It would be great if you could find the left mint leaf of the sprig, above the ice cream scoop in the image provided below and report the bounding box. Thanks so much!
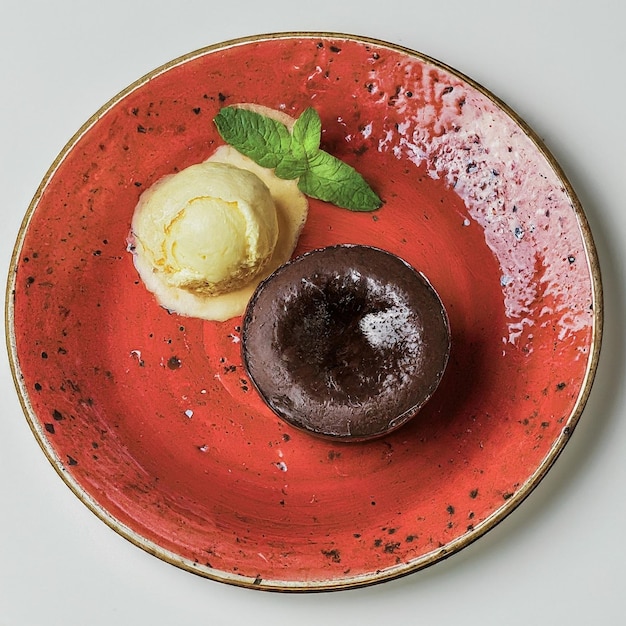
[214,107,291,168]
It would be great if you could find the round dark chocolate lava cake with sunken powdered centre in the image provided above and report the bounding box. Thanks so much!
[242,245,450,441]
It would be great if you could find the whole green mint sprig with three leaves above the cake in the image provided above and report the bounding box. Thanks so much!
[214,107,382,211]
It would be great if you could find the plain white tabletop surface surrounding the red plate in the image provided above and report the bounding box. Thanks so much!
[0,0,626,626]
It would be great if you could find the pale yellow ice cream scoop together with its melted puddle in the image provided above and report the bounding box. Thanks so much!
[130,106,308,321]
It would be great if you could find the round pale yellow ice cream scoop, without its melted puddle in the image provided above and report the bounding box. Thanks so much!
[132,162,278,296]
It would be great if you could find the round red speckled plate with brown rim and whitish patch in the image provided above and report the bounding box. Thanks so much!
[6,33,602,591]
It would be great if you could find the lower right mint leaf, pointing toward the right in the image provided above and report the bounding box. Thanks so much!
[298,150,382,211]
